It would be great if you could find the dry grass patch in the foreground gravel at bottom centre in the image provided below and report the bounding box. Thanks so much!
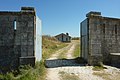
[59,71,79,80]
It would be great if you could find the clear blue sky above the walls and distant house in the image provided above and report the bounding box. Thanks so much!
[0,0,120,37]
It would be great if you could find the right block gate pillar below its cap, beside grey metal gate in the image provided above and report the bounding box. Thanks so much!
[88,16,103,65]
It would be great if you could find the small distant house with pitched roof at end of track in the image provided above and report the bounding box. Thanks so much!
[55,33,71,42]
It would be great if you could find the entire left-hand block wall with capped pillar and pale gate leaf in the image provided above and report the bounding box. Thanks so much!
[0,7,42,72]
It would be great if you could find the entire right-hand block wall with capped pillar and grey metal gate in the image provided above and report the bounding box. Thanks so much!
[81,12,120,65]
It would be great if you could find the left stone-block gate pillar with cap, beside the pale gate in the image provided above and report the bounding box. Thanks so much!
[15,9,36,66]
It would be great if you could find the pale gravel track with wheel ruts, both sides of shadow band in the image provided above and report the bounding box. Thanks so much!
[46,42,120,80]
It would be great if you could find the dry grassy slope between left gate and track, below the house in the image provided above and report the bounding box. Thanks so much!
[42,37,68,59]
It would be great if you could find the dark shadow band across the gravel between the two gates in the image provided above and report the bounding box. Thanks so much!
[45,58,86,68]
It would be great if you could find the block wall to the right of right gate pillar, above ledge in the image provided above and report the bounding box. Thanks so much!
[102,18,120,63]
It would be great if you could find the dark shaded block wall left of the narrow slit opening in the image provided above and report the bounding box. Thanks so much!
[0,12,19,72]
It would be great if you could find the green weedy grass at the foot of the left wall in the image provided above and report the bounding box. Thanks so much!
[0,62,45,80]
